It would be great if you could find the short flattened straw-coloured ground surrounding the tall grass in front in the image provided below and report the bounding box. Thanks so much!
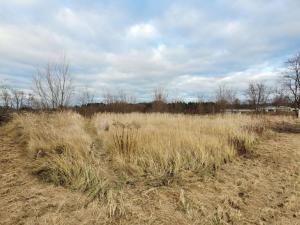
[0,125,300,225]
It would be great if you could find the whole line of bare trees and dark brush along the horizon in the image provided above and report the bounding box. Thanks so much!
[0,53,300,115]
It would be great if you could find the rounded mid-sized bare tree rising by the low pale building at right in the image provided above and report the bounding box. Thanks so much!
[246,82,270,111]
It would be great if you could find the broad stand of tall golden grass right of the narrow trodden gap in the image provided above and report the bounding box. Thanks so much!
[92,113,266,177]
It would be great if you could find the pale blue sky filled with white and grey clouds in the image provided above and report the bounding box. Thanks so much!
[0,0,300,101]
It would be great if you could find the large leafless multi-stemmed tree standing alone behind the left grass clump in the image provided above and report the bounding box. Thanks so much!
[33,57,73,109]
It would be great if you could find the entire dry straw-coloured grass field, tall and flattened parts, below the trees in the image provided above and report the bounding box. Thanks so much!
[0,112,300,224]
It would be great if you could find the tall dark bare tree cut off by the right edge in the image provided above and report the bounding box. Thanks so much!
[284,53,300,109]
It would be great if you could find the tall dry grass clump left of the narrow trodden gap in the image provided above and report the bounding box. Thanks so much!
[5,112,113,200]
